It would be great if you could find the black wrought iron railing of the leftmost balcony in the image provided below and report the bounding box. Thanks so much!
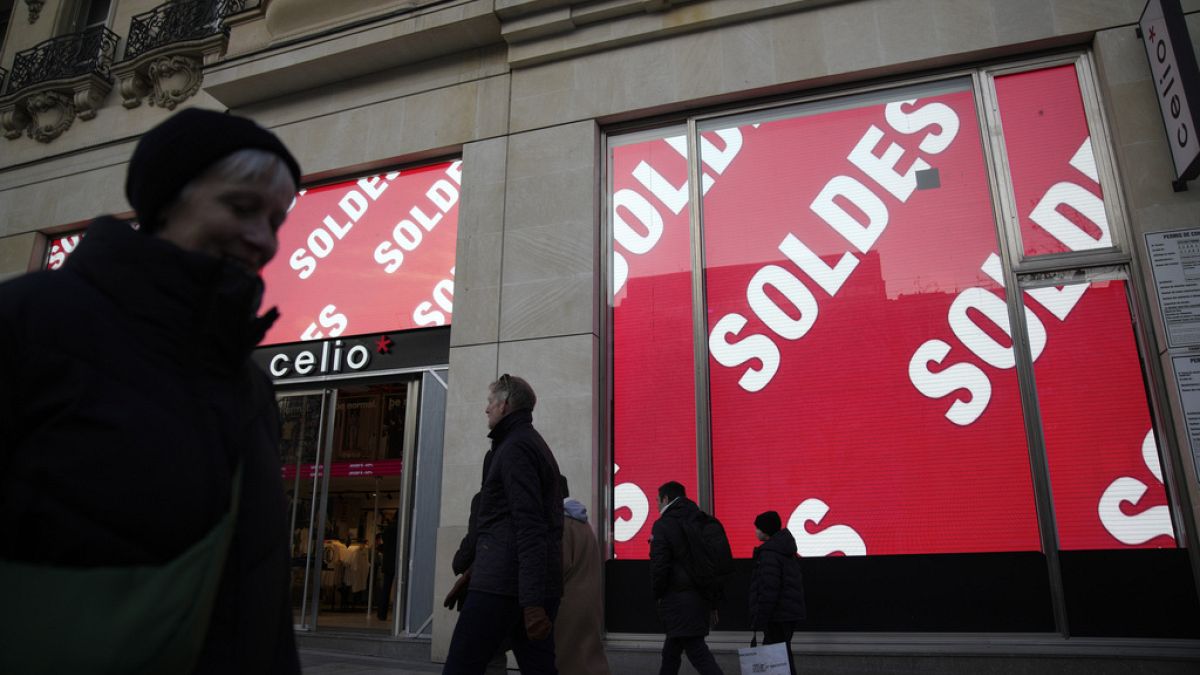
[6,25,120,94]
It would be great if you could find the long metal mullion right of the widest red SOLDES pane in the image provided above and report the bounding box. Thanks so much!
[973,65,1070,637]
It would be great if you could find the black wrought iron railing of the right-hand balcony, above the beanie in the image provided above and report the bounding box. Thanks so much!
[125,0,260,60]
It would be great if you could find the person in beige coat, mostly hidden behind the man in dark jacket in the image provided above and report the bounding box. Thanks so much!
[554,477,610,675]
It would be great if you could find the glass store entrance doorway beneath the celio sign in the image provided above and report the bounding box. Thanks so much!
[278,380,420,634]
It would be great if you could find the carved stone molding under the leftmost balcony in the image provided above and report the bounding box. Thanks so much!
[0,74,113,143]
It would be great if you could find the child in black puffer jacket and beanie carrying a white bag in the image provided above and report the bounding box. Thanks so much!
[750,510,805,675]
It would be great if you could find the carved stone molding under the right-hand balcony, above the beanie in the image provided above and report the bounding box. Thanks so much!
[113,34,229,110]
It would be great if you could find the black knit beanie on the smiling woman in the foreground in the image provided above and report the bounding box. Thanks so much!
[125,108,300,233]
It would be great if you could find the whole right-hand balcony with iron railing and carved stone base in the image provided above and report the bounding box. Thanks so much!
[113,0,260,109]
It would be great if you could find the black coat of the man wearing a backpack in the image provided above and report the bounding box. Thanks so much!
[650,497,714,638]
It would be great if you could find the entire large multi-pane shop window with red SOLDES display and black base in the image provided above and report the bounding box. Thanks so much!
[608,58,1200,637]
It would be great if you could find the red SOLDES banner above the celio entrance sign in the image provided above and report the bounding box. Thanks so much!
[263,161,462,345]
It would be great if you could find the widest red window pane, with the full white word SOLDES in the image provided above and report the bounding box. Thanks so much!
[703,82,1039,556]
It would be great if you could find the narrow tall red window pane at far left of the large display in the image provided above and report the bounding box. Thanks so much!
[611,127,696,558]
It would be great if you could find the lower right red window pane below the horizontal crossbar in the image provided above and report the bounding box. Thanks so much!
[1034,280,1175,550]
